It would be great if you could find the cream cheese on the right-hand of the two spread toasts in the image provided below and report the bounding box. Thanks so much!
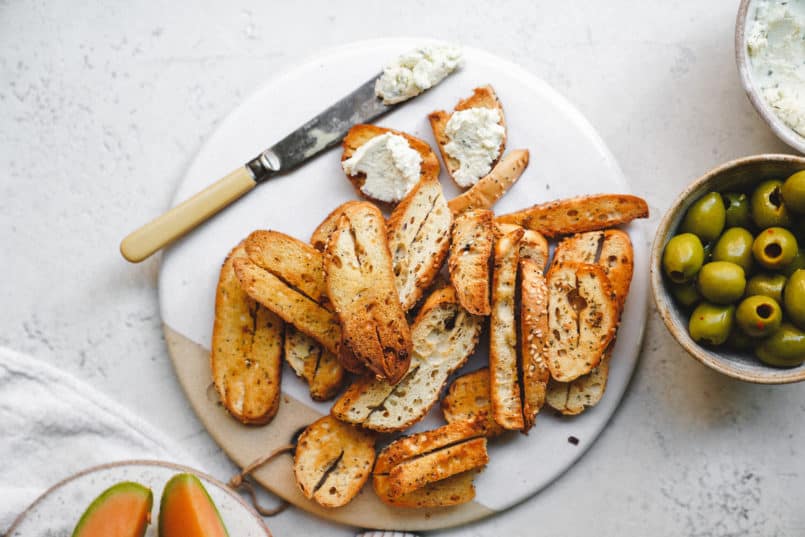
[444,107,506,188]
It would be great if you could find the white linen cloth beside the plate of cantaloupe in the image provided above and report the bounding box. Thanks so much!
[0,347,197,534]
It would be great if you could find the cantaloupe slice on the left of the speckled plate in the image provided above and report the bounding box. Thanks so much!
[73,481,154,537]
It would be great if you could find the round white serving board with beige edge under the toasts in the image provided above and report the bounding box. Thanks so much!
[159,38,648,530]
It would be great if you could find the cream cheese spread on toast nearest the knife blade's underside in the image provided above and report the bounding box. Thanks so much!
[341,132,422,203]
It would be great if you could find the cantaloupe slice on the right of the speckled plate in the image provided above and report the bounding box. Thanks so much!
[159,474,229,537]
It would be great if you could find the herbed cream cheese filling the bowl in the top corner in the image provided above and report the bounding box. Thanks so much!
[746,0,805,136]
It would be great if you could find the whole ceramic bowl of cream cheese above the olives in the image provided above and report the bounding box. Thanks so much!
[735,0,805,153]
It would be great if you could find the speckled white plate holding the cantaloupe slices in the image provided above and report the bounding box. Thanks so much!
[6,461,271,537]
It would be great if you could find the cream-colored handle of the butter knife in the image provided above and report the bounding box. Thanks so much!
[120,166,257,263]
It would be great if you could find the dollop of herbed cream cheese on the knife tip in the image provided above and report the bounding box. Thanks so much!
[375,45,461,104]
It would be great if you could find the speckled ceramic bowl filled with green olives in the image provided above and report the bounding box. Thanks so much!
[651,155,805,384]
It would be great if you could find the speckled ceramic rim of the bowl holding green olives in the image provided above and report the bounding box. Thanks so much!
[650,154,805,384]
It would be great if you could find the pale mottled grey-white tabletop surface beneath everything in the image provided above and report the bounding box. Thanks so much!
[0,0,805,537]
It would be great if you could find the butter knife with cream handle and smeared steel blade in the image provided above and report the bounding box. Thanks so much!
[120,74,392,263]
